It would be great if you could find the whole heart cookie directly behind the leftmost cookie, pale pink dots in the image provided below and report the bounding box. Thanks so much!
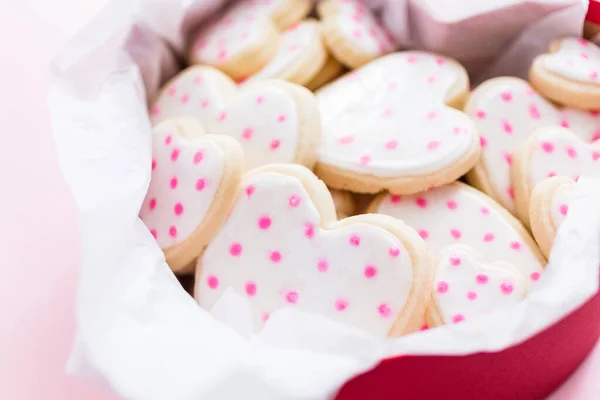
[150,66,321,168]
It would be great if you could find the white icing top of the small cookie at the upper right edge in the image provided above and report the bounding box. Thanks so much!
[543,38,600,83]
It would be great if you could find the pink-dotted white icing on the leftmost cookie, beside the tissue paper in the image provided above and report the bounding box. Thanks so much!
[140,122,225,249]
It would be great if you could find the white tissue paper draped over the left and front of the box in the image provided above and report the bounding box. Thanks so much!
[48,0,600,400]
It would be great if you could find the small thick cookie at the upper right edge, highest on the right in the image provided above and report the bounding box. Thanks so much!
[529,38,600,110]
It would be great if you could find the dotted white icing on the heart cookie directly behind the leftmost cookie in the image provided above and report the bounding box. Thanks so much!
[151,67,300,169]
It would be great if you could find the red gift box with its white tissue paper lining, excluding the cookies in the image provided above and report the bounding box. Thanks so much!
[49,0,600,400]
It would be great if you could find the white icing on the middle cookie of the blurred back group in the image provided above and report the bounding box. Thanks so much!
[244,21,321,83]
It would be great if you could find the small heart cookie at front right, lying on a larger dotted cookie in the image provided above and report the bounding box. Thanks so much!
[427,245,527,327]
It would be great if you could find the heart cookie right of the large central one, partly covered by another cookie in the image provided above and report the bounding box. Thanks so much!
[465,77,600,213]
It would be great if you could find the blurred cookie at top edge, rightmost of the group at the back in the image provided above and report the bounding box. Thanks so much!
[317,0,396,69]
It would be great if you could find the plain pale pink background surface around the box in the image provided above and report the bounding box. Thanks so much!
[0,0,600,400]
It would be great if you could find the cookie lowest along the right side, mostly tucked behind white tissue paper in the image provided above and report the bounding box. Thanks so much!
[529,176,576,257]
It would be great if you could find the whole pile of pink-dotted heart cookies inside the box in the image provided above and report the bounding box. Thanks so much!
[140,0,600,336]
